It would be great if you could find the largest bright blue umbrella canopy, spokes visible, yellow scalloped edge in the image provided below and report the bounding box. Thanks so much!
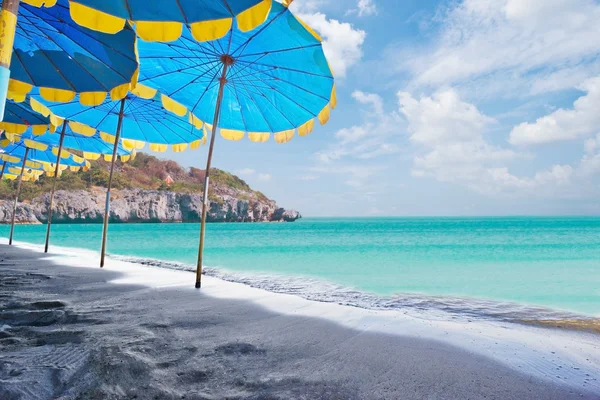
[138,2,336,142]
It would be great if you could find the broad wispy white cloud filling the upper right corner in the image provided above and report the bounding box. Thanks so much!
[393,0,600,97]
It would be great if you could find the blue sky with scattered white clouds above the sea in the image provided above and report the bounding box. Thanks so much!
[165,0,600,216]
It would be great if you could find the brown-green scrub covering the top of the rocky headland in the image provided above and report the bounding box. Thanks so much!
[0,153,268,202]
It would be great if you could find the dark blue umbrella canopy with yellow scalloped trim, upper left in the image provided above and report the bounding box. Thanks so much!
[4,0,138,105]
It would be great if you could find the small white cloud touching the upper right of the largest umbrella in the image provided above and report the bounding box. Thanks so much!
[292,11,367,78]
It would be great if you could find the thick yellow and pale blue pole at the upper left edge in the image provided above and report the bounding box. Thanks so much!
[0,0,20,121]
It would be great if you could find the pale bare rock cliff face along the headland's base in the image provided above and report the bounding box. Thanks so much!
[0,188,301,224]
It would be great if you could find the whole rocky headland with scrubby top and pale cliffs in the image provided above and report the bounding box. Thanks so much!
[0,153,300,224]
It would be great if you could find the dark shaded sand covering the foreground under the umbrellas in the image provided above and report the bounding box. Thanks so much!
[0,245,598,400]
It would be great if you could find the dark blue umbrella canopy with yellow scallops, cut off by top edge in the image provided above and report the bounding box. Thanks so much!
[25,0,272,42]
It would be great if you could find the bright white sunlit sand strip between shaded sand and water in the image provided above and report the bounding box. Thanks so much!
[0,239,600,394]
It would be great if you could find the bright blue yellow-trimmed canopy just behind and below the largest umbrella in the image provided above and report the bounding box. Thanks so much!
[29,85,204,151]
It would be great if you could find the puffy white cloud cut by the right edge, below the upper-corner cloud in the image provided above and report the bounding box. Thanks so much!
[510,76,600,146]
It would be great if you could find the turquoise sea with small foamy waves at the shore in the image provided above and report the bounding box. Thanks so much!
[0,217,600,318]
